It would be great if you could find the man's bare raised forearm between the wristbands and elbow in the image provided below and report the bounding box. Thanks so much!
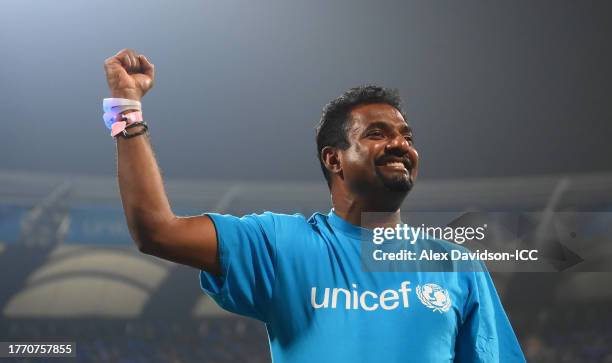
[117,135,174,250]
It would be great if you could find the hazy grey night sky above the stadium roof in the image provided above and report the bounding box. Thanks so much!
[0,0,612,180]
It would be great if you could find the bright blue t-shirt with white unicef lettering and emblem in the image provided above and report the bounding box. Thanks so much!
[200,211,525,363]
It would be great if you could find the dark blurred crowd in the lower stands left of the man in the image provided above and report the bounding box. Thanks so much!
[0,318,270,363]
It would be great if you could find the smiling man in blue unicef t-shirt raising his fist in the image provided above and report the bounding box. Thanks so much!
[105,49,524,363]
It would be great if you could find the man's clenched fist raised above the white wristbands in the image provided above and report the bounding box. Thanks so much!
[104,49,155,101]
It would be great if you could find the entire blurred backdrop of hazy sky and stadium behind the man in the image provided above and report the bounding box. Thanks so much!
[0,0,612,363]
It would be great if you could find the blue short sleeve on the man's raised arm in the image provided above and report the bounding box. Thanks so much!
[200,212,276,321]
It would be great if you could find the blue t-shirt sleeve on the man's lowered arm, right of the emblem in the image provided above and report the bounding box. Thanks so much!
[455,264,525,363]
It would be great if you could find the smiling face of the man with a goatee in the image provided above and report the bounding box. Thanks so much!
[339,103,419,194]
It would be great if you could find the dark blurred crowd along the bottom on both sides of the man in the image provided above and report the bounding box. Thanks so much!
[0,303,612,363]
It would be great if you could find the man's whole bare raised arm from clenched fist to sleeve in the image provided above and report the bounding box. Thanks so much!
[104,49,219,273]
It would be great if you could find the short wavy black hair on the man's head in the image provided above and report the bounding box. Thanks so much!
[316,85,406,187]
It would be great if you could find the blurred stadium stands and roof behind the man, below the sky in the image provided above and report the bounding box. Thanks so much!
[0,172,612,362]
